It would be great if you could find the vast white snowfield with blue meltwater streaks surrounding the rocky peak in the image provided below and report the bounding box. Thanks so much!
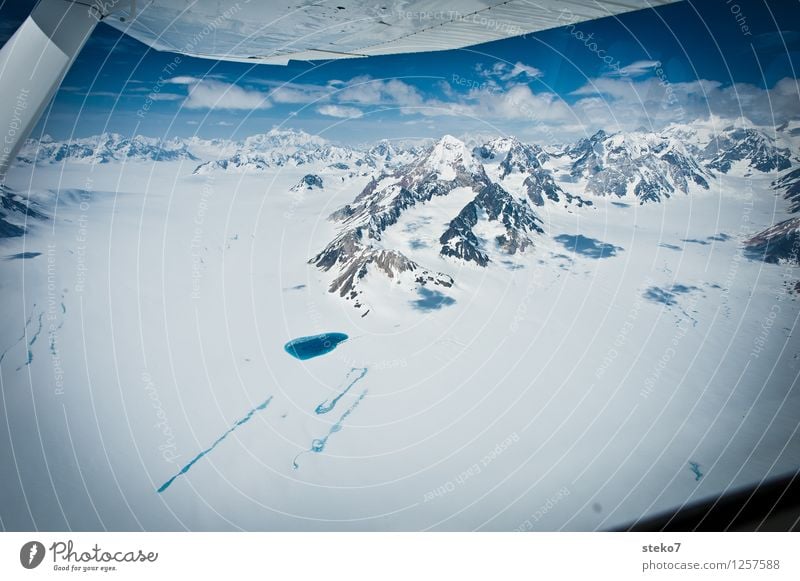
[0,125,800,530]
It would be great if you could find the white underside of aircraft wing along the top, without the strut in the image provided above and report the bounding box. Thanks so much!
[105,0,674,64]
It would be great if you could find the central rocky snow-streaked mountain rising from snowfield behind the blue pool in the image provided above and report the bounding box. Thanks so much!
[310,135,543,306]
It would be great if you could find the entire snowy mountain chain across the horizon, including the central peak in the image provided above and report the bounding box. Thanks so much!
[7,122,800,300]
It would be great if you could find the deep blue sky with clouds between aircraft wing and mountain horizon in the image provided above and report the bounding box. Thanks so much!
[0,0,800,143]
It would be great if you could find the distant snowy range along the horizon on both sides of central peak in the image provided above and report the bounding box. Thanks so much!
[18,124,800,182]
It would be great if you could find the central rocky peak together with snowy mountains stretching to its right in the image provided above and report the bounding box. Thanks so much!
[310,125,800,310]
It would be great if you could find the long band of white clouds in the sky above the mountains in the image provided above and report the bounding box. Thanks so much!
[168,68,800,140]
